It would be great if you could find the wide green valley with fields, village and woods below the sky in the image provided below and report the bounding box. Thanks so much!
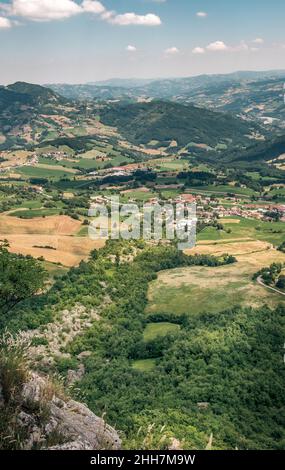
[0,72,285,450]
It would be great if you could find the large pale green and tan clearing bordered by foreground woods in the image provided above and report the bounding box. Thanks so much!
[146,248,285,316]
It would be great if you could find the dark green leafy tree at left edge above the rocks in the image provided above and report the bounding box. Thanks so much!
[0,240,46,313]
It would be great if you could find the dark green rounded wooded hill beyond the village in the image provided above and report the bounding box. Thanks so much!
[100,101,256,147]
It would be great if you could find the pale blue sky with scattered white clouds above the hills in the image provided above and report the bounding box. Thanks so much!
[0,0,285,84]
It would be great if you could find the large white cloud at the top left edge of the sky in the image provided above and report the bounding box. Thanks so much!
[11,0,82,21]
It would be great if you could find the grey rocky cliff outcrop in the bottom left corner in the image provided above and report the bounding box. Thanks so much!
[0,373,121,450]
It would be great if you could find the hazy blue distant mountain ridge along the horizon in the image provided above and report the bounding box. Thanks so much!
[45,70,285,128]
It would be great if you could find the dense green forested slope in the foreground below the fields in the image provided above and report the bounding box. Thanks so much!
[0,241,285,449]
